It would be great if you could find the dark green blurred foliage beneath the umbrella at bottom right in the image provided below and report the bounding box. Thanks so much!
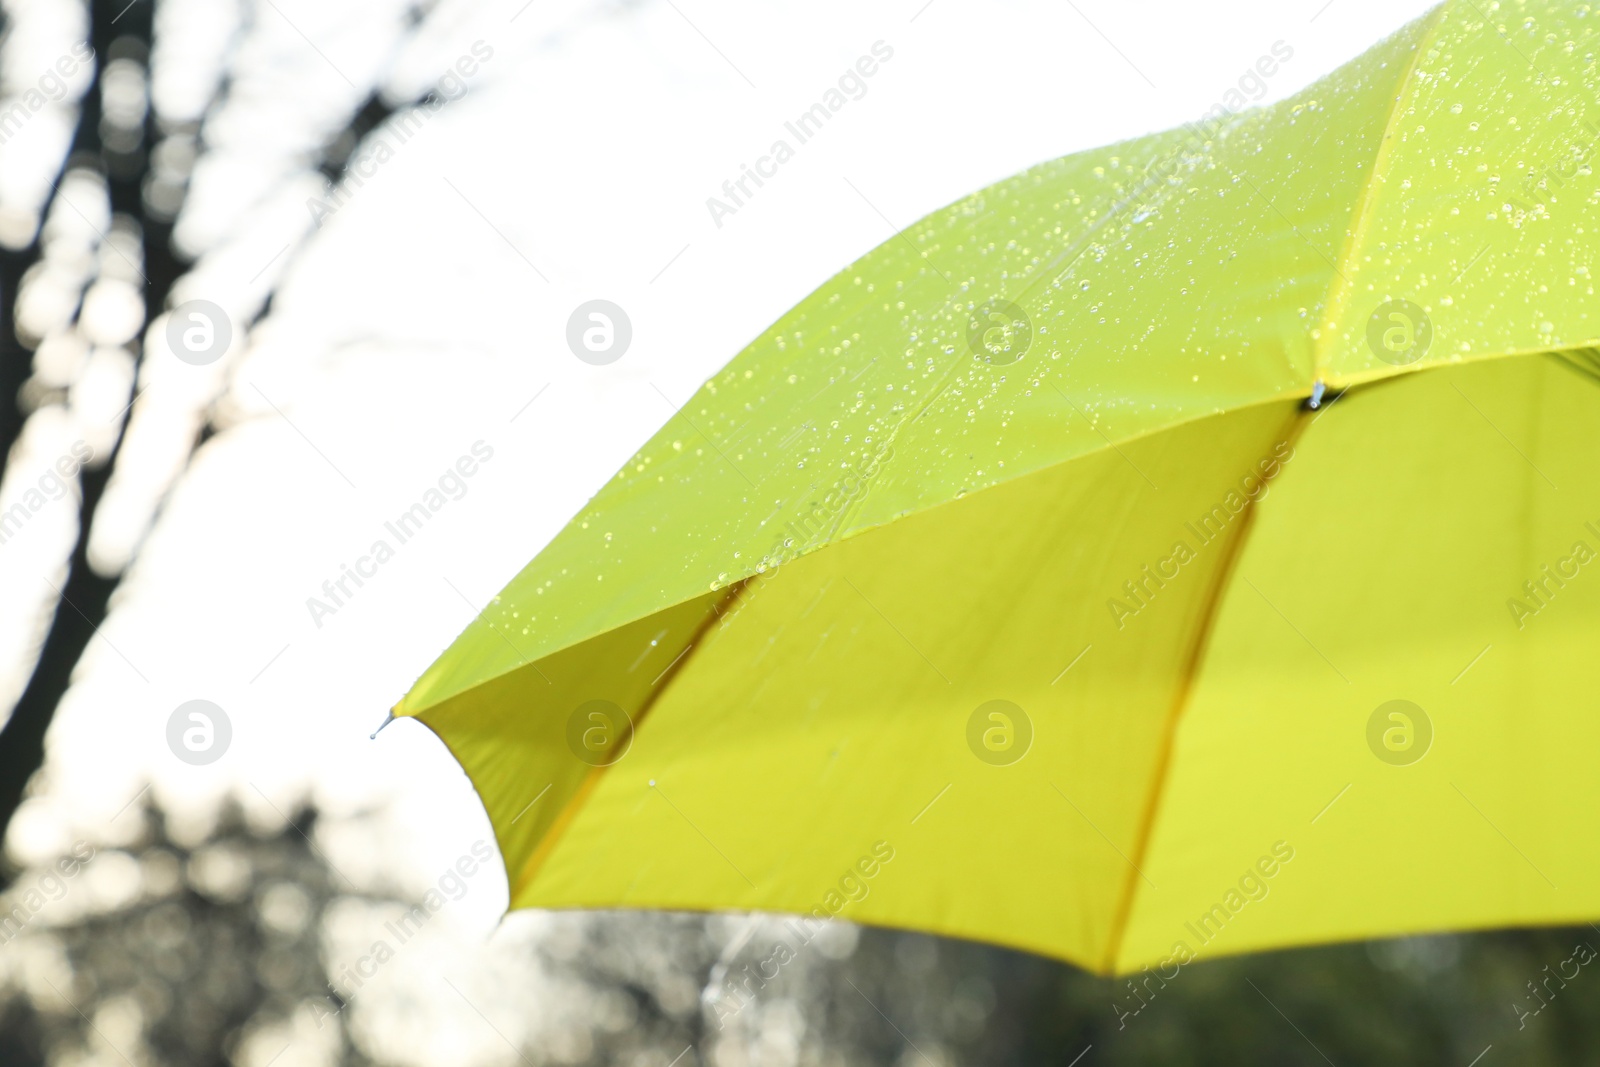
[846,926,1600,1067]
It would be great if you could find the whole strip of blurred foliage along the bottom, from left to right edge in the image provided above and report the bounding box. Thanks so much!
[0,796,1600,1067]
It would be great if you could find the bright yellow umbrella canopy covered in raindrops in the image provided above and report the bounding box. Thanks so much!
[395,0,1600,971]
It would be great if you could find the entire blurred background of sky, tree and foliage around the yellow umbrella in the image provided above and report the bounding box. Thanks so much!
[0,0,1600,1067]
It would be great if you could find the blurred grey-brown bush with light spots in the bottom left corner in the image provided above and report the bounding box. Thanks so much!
[0,806,385,1065]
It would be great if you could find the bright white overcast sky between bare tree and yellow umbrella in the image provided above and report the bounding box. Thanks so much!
[0,0,1446,1062]
